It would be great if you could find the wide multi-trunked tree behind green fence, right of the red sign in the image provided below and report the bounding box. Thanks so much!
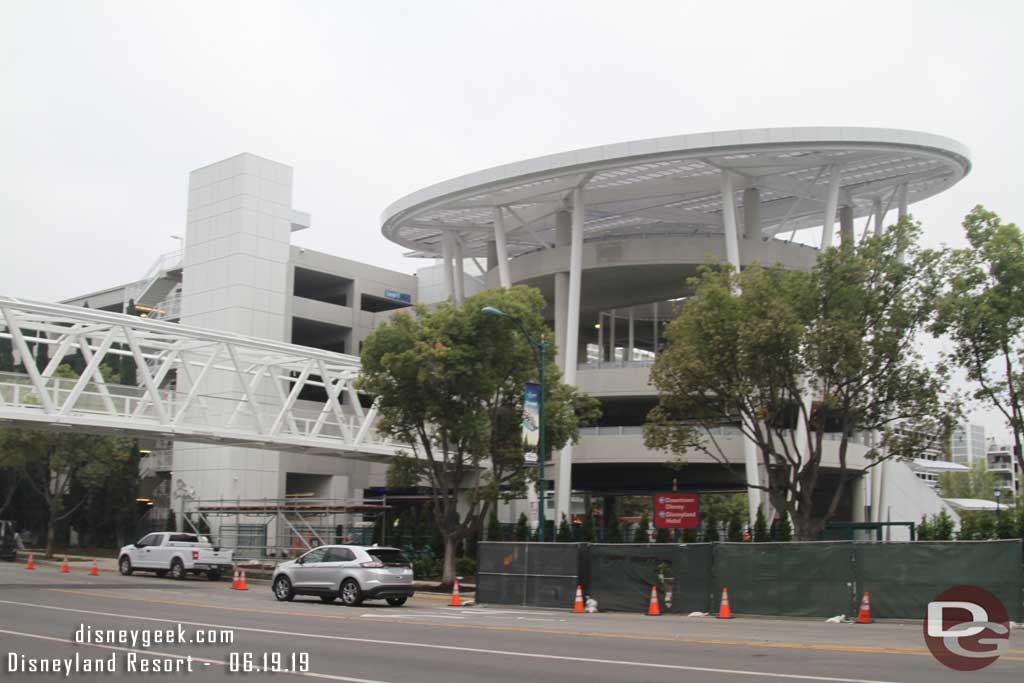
[644,219,951,540]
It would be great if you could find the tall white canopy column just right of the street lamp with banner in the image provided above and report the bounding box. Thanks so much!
[554,187,586,524]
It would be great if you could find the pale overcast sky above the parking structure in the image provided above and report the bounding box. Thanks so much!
[0,0,1024,438]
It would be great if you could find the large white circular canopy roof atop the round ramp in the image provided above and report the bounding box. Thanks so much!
[382,128,971,257]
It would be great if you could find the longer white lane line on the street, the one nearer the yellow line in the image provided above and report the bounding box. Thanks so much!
[0,600,895,683]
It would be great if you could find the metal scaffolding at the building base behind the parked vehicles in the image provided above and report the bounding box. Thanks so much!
[183,496,388,560]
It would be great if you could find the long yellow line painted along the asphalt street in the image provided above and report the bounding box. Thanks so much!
[44,588,1024,661]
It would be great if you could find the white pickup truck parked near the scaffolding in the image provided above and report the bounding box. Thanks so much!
[118,531,233,581]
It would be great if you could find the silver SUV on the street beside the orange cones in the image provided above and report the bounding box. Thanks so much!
[270,546,414,607]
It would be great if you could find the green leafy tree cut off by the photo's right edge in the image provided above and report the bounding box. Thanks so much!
[931,205,1024,485]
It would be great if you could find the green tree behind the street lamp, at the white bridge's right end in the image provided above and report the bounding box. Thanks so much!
[358,287,597,584]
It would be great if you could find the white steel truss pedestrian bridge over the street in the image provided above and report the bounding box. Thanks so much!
[0,296,404,460]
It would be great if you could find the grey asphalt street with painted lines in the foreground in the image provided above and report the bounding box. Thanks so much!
[0,562,1024,683]
